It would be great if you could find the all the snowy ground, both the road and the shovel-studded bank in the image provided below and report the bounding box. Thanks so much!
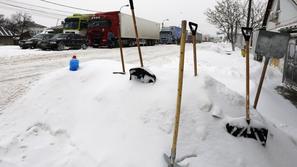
[0,43,297,167]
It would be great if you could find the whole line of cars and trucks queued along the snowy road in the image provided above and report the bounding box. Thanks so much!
[19,11,201,50]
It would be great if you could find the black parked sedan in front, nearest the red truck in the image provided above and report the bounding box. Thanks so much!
[38,33,88,51]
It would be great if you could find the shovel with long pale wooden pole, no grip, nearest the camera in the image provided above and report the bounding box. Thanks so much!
[164,20,196,167]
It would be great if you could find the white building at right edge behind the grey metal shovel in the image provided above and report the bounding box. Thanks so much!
[263,0,297,90]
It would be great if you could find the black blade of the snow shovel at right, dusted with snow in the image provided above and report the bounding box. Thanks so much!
[226,123,268,146]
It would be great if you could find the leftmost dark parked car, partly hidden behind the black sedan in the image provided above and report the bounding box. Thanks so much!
[19,34,54,49]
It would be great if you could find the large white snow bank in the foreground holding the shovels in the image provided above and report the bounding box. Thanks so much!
[0,58,297,167]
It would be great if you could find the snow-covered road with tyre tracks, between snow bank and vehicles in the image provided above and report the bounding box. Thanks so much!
[0,45,178,111]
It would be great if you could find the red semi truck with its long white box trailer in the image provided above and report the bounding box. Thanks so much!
[87,11,160,47]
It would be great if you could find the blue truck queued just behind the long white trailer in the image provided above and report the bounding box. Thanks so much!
[160,26,181,44]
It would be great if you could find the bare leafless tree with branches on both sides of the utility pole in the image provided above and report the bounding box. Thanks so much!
[206,0,267,51]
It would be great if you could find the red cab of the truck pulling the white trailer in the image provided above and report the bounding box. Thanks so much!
[87,11,120,47]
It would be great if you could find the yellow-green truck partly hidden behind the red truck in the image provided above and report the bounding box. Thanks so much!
[63,14,93,36]
